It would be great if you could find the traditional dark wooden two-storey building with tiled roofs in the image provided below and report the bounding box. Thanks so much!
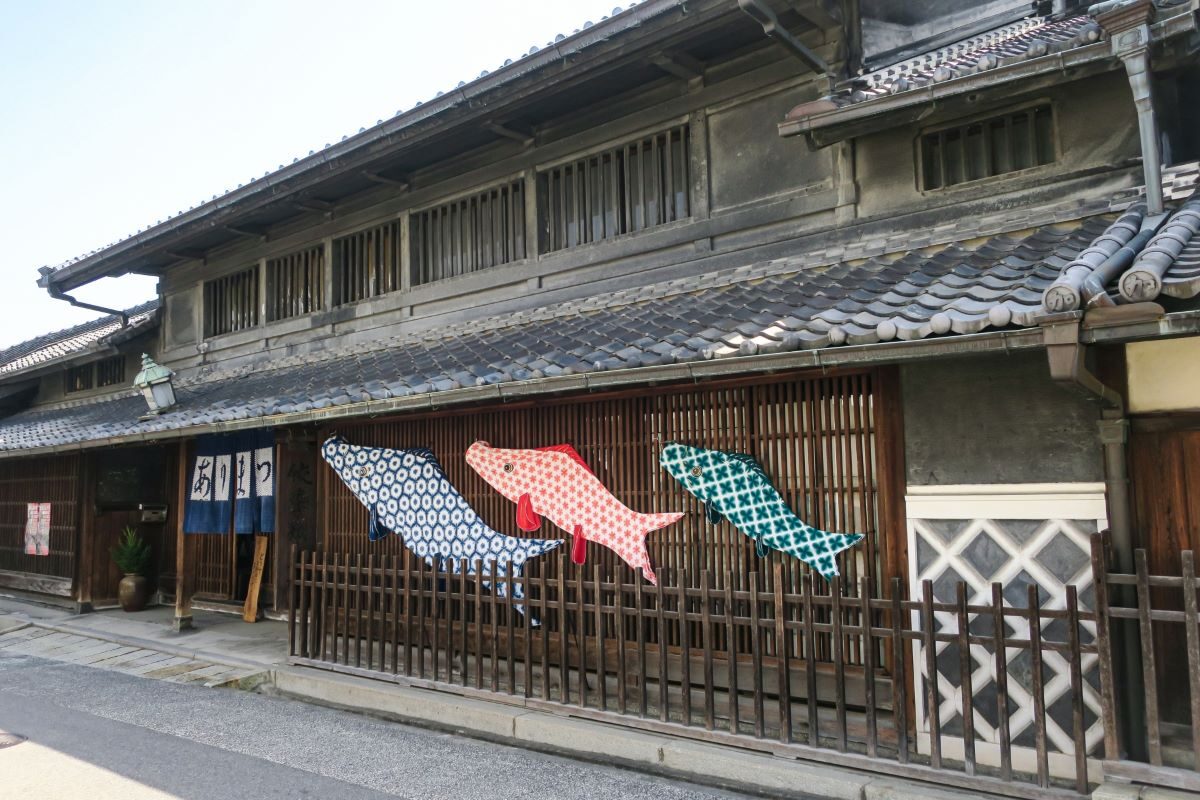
[7,0,1200,795]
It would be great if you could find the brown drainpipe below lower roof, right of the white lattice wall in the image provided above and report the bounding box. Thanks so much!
[1038,311,1145,758]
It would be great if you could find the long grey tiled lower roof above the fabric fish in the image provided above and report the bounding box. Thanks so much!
[0,164,1200,451]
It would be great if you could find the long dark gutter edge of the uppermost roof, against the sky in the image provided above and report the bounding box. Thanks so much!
[37,0,696,289]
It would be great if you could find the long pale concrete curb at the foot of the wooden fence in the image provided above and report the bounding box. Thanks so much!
[264,667,996,800]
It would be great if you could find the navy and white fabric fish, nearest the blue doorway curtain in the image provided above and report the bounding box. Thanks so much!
[320,437,563,585]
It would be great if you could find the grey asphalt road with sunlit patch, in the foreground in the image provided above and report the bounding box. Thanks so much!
[0,652,753,800]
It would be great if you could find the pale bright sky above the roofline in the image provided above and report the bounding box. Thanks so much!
[0,0,628,347]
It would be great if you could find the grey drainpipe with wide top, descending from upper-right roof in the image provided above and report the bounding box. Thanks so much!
[1088,0,1163,216]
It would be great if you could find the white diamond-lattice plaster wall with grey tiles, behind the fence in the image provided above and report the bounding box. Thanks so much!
[907,483,1108,776]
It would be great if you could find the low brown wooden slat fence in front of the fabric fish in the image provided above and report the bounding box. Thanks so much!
[289,551,1098,796]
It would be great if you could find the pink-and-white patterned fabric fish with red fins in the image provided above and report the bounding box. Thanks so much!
[467,441,683,584]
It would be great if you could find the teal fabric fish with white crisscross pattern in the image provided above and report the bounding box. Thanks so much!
[659,441,863,581]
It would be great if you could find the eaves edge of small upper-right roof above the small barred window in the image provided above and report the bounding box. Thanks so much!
[779,8,1196,148]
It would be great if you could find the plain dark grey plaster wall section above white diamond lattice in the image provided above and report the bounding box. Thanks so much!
[901,353,1104,487]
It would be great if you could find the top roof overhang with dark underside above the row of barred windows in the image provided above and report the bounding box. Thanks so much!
[38,0,821,291]
